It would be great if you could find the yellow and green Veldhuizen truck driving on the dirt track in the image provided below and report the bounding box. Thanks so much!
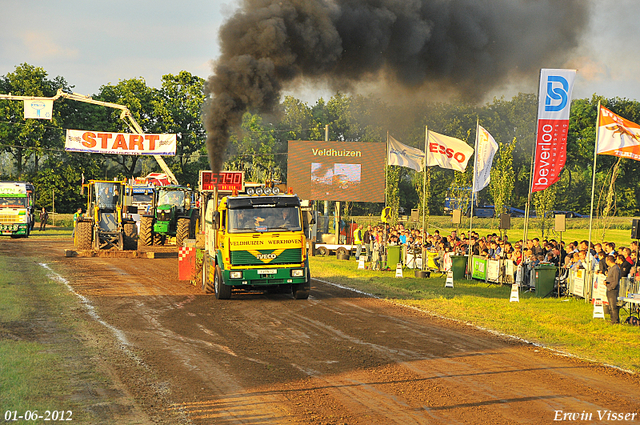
[202,194,311,299]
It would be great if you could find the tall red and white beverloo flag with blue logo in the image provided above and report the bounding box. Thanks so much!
[531,69,576,192]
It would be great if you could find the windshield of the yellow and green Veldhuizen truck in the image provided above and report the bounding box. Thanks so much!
[229,207,302,233]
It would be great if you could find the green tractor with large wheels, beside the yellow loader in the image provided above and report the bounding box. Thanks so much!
[140,186,197,246]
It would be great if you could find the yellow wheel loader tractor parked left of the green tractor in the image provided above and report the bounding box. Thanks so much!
[74,180,138,251]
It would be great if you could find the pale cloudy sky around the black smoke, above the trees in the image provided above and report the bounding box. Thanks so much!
[0,0,640,104]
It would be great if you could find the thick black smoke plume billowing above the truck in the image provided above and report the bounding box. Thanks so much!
[205,0,589,171]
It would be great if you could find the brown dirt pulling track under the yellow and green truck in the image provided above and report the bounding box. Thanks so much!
[0,238,640,424]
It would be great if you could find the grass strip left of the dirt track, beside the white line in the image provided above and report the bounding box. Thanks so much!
[0,257,84,421]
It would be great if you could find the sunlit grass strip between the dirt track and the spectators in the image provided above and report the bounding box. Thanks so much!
[311,257,640,372]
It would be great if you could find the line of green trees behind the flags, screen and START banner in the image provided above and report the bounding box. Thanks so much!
[0,64,640,216]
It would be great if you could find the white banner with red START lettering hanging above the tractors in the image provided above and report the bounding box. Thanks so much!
[64,130,176,155]
